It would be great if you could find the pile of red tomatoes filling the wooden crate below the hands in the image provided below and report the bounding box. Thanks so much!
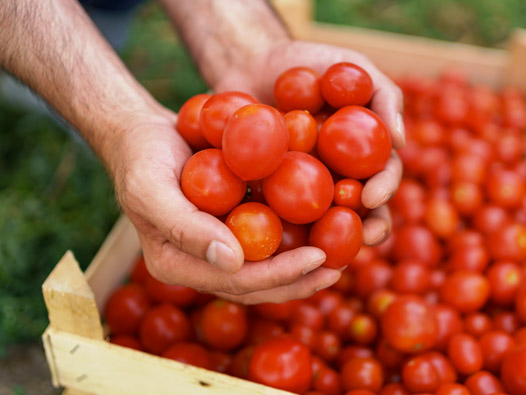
[105,66,526,395]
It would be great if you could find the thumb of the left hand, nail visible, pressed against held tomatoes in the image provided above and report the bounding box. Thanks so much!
[142,187,244,273]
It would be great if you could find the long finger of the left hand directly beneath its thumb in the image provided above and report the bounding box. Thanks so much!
[140,235,325,295]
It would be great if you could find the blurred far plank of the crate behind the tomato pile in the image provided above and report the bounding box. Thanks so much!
[299,22,508,87]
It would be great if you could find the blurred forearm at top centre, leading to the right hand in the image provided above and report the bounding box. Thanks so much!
[160,0,289,87]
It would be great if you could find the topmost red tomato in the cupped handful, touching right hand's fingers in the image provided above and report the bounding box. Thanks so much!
[321,62,374,108]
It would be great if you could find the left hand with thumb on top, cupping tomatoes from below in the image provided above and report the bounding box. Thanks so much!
[109,110,341,304]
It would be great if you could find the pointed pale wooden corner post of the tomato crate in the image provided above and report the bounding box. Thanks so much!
[42,251,103,339]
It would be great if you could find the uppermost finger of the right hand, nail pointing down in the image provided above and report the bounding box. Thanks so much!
[371,75,405,149]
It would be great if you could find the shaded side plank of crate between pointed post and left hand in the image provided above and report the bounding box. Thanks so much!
[86,215,141,312]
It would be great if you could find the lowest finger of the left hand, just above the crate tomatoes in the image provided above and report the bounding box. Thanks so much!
[216,267,341,304]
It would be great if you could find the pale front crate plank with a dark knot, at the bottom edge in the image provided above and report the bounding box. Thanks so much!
[46,328,289,395]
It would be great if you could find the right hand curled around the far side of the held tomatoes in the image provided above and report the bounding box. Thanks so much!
[215,39,405,245]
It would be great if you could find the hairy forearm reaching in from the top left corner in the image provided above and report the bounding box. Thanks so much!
[0,0,163,173]
